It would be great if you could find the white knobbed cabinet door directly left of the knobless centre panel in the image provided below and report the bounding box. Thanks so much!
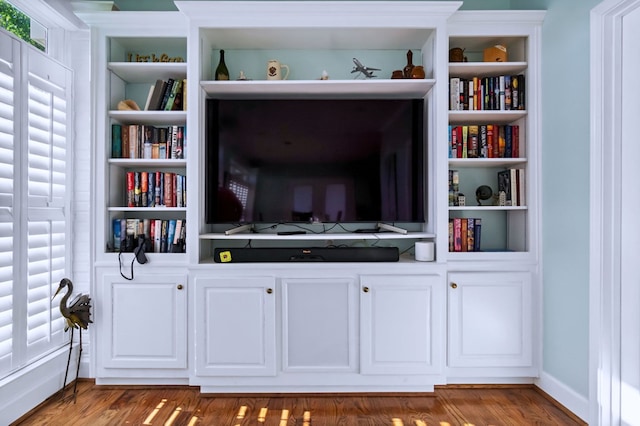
[195,277,276,376]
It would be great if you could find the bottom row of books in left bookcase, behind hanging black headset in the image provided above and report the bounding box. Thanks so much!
[113,219,187,253]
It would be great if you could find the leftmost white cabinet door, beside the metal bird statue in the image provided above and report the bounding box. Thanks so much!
[98,274,187,369]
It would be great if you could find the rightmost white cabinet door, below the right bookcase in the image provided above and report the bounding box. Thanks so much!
[448,272,532,367]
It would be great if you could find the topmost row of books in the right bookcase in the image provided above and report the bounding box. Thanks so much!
[449,74,526,111]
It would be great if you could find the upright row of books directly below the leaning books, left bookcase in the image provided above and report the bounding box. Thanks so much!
[111,123,186,160]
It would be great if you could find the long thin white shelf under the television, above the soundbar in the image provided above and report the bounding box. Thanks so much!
[200,232,435,241]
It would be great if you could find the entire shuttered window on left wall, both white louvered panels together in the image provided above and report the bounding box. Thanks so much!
[0,27,71,378]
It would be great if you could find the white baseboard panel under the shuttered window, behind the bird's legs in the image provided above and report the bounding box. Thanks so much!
[0,344,77,425]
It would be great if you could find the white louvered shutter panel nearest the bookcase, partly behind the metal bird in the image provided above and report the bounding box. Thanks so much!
[26,46,69,359]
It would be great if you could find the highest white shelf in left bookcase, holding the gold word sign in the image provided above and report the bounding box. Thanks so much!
[107,62,187,83]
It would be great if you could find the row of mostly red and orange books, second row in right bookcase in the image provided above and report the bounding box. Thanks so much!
[449,124,520,158]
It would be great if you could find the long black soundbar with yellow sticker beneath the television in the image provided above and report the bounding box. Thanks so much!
[213,247,400,263]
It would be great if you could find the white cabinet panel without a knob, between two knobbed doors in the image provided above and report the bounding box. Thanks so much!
[282,278,357,372]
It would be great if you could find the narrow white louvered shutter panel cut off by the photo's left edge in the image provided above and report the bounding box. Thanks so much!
[0,36,20,377]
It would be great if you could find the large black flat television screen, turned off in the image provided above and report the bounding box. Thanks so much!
[204,99,425,224]
